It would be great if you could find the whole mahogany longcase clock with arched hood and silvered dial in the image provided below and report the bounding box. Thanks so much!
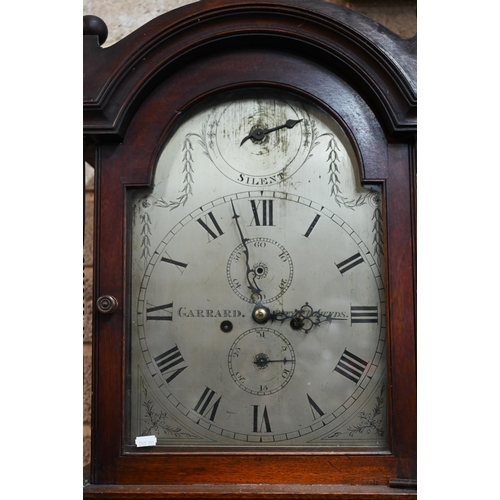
[84,0,416,499]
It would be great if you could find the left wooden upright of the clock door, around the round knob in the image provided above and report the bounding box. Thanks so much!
[91,144,126,483]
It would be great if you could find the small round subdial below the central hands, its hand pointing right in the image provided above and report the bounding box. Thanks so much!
[228,327,295,396]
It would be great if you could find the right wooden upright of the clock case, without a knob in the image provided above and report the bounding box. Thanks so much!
[386,144,417,479]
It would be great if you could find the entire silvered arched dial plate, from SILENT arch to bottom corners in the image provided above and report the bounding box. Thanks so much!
[128,89,387,449]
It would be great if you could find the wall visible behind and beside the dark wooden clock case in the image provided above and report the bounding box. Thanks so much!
[83,0,417,465]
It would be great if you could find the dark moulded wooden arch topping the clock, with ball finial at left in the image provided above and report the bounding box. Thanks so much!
[83,0,417,141]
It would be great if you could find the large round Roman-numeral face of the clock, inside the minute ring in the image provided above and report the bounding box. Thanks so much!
[137,191,385,443]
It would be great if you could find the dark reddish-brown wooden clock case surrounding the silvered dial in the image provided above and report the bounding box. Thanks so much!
[84,0,416,498]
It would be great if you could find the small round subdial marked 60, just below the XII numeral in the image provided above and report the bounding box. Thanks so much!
[226,238,293,304]
